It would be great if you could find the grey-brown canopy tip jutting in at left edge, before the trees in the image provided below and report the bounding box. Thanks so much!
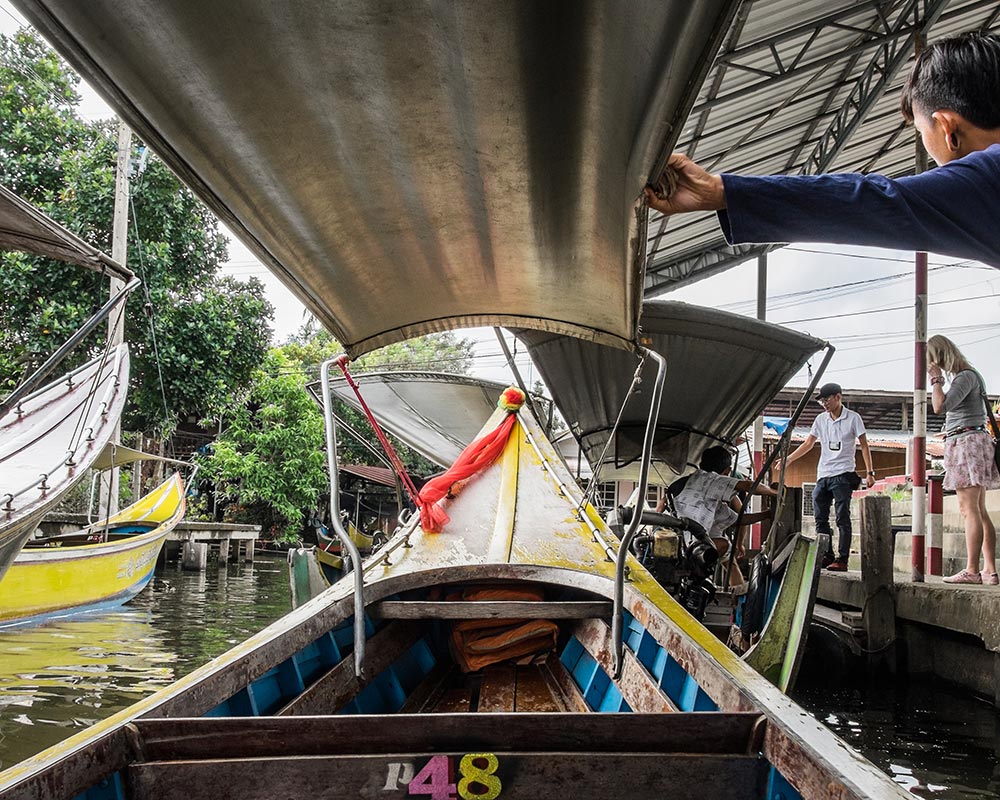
[0,186,132,283]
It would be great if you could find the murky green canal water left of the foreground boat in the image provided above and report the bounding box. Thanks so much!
[0,554,291,768]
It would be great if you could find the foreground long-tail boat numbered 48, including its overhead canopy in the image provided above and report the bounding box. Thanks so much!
[0,0,906,800]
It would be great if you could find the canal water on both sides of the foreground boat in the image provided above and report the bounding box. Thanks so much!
[0,556,1000,800]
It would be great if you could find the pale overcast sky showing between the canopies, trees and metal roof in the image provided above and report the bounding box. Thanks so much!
[7,0,1000,392]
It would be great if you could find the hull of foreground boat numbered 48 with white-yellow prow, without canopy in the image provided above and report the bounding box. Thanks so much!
[0,411,907,800]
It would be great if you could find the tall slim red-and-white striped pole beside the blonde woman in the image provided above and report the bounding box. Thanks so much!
[910,253,928,583]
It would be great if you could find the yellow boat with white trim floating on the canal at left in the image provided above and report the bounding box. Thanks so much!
[0,473,185,625]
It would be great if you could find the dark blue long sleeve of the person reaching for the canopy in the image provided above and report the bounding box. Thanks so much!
[719,144,1000,267]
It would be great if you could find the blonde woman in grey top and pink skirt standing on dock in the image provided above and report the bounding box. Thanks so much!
[927,336,1000,584]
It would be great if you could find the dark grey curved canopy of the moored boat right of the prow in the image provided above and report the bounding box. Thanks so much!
[517,300,826,485]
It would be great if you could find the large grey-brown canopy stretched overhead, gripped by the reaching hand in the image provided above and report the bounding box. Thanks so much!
[16,0,739,357]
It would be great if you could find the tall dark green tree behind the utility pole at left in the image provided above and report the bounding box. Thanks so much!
[0,31,273,433]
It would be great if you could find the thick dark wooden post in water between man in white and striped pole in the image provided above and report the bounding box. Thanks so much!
[861,495,896,673]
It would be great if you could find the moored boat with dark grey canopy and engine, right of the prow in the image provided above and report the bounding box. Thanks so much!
[518,300,832,691]
